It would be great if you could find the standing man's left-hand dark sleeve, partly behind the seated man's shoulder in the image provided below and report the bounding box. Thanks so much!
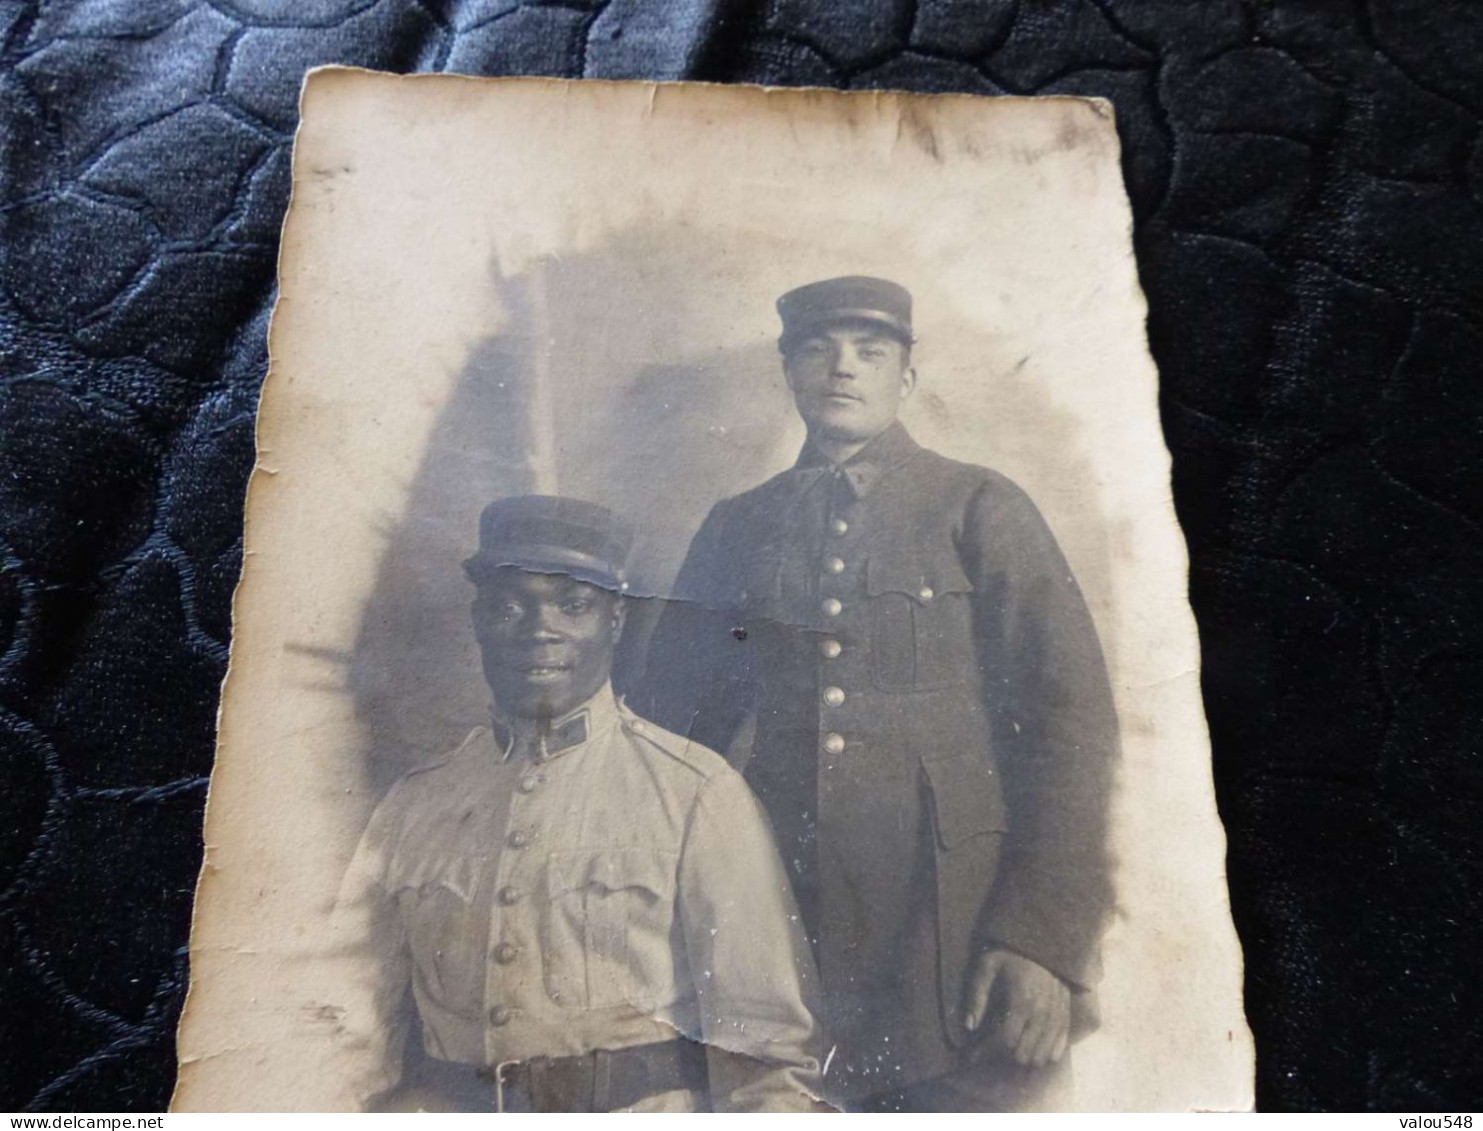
[626,501,756,753]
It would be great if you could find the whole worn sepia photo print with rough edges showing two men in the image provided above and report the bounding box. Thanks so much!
[175,70,1252,1112]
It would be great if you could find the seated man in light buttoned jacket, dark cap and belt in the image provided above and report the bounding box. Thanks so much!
[329,497,819,1112]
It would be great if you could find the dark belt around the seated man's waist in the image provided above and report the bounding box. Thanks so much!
[479,1041,707,1112]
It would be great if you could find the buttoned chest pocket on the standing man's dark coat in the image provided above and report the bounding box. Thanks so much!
[865,548,979,691]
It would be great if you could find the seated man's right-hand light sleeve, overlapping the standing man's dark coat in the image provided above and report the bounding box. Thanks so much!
[679,771,823,1112]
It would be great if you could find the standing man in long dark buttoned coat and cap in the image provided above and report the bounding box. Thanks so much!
[645,277,1118,1110]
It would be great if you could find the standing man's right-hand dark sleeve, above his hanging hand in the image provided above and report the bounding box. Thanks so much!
[961,479,1118,989]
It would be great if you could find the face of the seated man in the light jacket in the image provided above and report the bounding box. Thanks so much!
[473,568,623,719]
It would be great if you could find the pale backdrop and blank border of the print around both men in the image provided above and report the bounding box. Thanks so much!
[176,71,1252,1110]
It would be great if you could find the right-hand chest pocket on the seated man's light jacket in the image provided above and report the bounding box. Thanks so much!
[541,848,679,1012]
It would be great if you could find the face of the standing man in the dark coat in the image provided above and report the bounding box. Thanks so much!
[783,323,916,442]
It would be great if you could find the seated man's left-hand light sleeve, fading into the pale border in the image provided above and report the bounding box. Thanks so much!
[326,786,411,1110]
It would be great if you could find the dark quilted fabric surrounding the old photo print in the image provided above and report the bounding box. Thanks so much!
[0,0,1483,1112]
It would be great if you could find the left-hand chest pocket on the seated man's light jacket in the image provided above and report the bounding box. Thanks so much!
[387,851,489,1011]
